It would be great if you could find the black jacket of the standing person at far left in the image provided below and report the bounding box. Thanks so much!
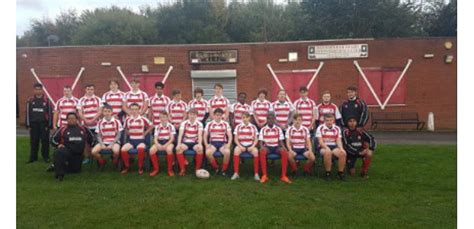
[25,95,54,128]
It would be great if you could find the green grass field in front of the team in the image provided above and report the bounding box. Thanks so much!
[16,137,456,228]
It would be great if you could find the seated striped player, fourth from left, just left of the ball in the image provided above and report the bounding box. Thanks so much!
[175,108,203,176]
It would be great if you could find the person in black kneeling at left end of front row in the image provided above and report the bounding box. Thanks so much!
[51,112,95,181]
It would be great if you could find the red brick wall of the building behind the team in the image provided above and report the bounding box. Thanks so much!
[17,37,457,129]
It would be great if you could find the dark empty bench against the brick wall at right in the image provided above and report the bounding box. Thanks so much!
[370,112,425,130]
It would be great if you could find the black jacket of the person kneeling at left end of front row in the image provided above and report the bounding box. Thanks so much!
[51,125,95,154]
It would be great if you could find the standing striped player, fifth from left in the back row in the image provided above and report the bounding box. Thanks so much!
[148,82,171,126]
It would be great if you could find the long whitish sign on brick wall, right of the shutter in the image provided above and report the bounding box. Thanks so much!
[308,44,369,60]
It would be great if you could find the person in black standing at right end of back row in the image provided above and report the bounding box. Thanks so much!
[339,86,369,127]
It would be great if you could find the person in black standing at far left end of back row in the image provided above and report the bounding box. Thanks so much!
[25,83,53,163]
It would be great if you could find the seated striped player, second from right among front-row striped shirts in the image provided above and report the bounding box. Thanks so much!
[286,114,316,175]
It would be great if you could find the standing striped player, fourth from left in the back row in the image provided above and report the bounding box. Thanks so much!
[122,79,149,116]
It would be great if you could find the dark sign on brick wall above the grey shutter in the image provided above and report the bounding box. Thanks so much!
[189,50,239,64]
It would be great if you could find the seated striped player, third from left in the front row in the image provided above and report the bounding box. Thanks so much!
[150,111,176,177]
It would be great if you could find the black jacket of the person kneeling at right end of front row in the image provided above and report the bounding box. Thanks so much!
[342,128,377,155]
